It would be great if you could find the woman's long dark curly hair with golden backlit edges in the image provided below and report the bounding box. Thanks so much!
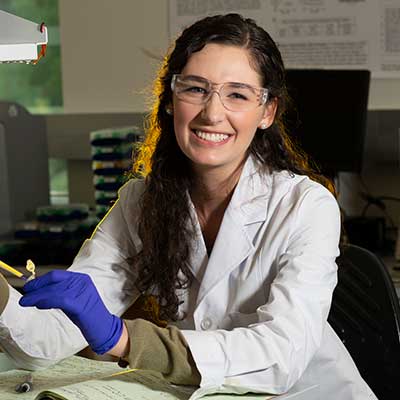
[133,14,333,320]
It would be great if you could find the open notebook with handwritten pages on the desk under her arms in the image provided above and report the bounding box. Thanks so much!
[0,353,318,400]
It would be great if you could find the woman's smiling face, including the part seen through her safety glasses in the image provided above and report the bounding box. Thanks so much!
[172,43,277,177]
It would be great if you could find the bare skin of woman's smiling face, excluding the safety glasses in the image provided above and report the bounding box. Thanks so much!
[173,43,276,175]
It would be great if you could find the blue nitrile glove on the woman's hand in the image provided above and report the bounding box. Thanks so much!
[19,270,123,354]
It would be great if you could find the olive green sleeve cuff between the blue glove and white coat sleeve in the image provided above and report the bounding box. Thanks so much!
[119,318,201,385]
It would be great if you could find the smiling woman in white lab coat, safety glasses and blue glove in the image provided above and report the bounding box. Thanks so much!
[0,14,375,400]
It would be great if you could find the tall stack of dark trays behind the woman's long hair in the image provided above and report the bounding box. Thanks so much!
[90,126,143,218]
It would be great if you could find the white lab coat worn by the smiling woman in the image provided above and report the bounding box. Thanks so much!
[0,157,376,400]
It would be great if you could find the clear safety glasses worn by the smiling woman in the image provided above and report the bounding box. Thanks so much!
[171,74,268,111]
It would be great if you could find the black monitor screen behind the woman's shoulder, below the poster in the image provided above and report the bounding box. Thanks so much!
[286,69,370,175]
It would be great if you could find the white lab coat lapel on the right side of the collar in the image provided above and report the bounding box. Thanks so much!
[197,157,268,306]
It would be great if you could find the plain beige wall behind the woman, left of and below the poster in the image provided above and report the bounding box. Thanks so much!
[59,0,400,113]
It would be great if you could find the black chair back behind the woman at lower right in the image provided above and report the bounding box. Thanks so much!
[328,245,400,400]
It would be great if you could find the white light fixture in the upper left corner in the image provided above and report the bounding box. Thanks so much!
[0,10,48,64]
